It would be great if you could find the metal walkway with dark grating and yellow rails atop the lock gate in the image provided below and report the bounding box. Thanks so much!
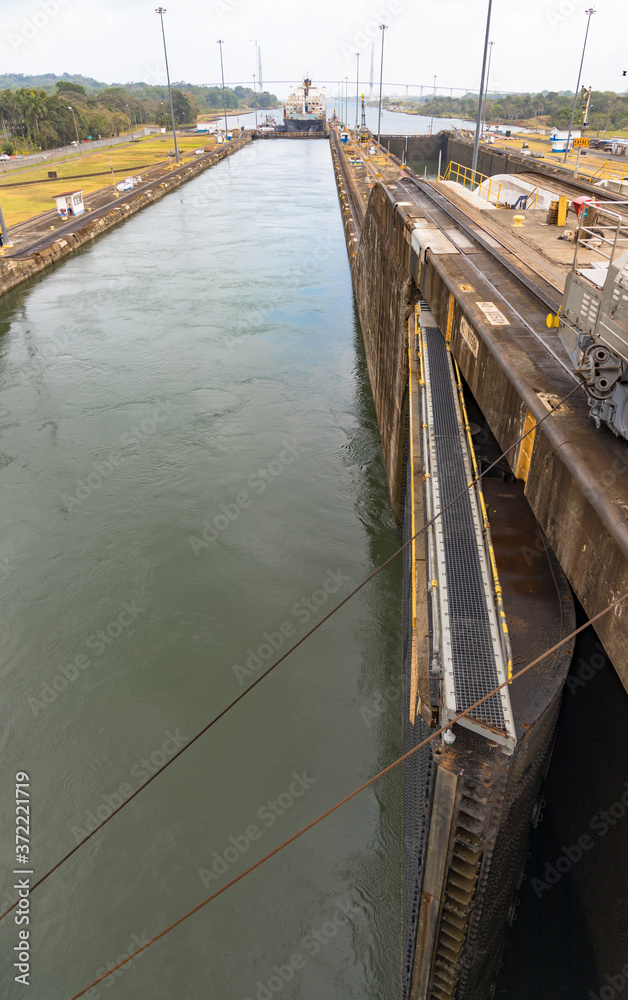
[416,303,516,750]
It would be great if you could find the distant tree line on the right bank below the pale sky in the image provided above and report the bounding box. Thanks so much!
[389,90,628,130]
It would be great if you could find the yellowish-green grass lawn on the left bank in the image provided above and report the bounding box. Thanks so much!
[0,134,221,226]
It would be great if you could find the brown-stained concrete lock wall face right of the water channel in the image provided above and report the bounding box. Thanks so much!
[336,144,628,690]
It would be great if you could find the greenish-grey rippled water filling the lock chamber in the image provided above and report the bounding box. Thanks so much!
[0,142,401,1000]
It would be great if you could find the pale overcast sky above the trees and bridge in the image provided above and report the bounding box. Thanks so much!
[0,0,628,96]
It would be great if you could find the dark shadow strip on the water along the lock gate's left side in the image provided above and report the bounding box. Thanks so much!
[336,299,402,997]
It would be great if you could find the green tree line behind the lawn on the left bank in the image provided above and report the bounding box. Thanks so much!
[0,80,278,153]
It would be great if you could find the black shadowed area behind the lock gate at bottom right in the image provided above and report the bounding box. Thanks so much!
[495,606,628,1000]
